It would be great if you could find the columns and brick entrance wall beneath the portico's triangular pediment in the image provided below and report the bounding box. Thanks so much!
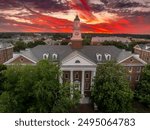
[62,67,96,98]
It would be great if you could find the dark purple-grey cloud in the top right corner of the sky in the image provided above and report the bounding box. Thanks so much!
[97,0,150,17]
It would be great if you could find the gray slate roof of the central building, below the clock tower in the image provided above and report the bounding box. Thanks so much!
[22,45,131,63]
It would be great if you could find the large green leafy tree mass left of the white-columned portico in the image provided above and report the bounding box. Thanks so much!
[0,60,80,112]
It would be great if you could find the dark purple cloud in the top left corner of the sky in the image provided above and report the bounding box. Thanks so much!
[0,0,69,12]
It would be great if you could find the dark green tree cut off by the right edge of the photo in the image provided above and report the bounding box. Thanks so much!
[135,65,150,107]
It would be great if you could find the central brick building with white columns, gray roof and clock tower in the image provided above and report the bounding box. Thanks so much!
[5,16,146,103]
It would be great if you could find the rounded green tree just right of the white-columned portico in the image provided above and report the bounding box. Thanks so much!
[92,61,133,112]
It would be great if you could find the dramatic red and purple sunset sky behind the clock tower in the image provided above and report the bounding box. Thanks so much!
[0,0,150,34]
